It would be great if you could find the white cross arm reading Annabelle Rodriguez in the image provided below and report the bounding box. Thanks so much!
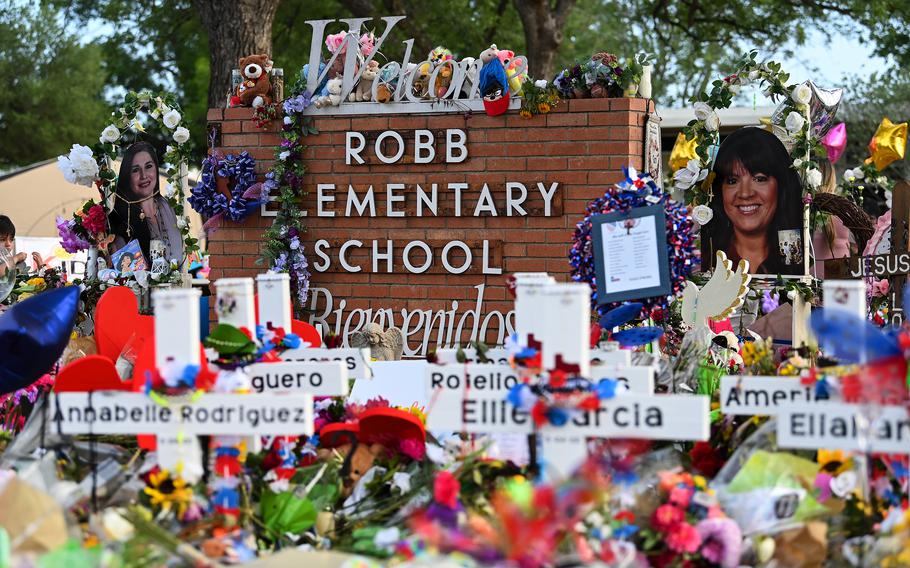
[55,391,313,436]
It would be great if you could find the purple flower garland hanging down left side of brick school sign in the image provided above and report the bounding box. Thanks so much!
[257,83,318,317]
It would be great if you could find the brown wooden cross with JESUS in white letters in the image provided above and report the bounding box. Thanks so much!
[825,181,910,324]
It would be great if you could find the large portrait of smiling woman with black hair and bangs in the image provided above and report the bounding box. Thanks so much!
[702,127,804,275]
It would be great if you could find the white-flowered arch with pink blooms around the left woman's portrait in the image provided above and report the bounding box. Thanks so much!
[57,91,199,264]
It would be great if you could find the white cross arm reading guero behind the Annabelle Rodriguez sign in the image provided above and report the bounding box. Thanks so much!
[245,361,348,396]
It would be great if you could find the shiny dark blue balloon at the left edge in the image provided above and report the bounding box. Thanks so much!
[0,286,79,394]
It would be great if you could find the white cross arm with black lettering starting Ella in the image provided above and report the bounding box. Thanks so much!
[777,402,910,454]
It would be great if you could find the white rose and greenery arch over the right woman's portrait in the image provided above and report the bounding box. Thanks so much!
[674,50,825,225]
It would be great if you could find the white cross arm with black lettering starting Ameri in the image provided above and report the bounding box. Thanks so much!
[720,375,828,416]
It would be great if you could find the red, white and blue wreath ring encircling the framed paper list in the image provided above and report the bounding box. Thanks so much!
[569,168,699,316]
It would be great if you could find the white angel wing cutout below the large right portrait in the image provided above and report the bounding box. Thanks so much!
[681,251,752,329]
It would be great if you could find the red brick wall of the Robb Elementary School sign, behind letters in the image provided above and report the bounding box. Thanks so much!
[208,98,645,352]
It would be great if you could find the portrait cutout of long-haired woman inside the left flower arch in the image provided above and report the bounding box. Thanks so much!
[110,142,183,262]
